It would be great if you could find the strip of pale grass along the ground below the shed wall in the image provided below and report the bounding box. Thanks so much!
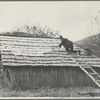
[0,87,100,97]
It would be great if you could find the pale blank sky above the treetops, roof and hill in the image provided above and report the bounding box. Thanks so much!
[0,1,100,41]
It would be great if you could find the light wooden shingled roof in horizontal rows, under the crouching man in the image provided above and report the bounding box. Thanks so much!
[0,36,100,67]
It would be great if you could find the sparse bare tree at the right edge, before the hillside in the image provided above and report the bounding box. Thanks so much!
[84,11,100,56]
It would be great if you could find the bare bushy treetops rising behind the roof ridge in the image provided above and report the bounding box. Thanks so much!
[0,25,59,38]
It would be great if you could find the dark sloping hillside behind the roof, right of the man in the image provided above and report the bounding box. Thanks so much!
[75,33,100,57]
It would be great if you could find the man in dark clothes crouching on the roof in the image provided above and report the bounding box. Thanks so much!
[58,36,80,55]
